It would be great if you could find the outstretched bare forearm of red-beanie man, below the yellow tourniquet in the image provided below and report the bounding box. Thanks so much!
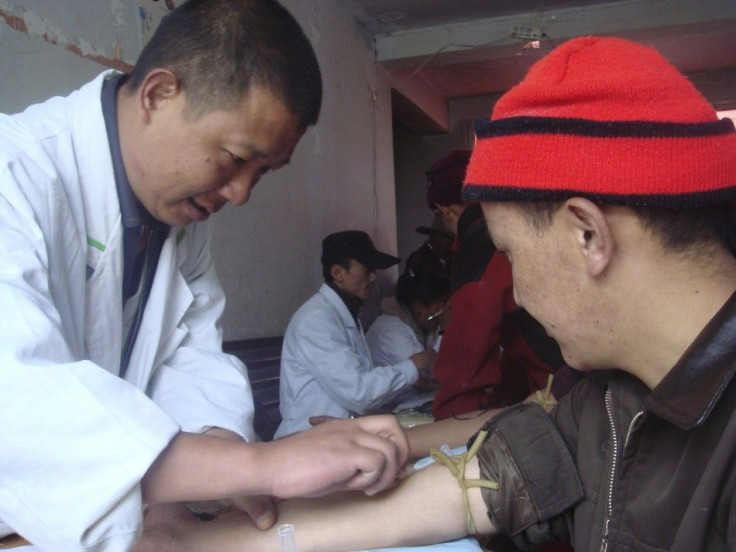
[167,459,494,552]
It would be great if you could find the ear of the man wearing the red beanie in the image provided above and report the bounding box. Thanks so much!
[564,197,615,276]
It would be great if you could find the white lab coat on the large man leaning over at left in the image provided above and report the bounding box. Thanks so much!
[0,74,253,552]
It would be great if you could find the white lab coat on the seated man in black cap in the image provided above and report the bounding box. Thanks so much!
[275,284,419,438]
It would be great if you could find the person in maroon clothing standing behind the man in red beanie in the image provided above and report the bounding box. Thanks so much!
[427,150,570,420]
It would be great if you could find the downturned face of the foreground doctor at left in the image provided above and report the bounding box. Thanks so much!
[131,87,304,226]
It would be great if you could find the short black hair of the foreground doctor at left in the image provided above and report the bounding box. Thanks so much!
[130,0,322,128]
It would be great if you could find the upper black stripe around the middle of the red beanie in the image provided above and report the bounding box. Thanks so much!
[474,117,734,139]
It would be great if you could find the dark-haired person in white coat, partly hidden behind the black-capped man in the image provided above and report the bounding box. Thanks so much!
[365,268,450,365]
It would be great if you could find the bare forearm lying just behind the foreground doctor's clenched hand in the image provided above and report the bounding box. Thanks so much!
[406,409,500,460]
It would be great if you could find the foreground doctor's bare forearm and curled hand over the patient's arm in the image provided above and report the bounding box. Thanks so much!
[142,416,409,504]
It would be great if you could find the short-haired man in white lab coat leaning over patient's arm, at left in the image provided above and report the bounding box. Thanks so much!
[0,0,414,552]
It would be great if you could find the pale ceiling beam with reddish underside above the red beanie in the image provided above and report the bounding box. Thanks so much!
[374,0,736,134]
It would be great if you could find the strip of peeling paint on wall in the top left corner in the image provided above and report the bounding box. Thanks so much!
[0,0,132,72]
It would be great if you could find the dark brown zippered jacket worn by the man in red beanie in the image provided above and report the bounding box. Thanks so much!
[478,296,736,552]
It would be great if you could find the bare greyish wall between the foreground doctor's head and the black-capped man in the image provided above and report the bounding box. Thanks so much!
[214,0,396,339]
